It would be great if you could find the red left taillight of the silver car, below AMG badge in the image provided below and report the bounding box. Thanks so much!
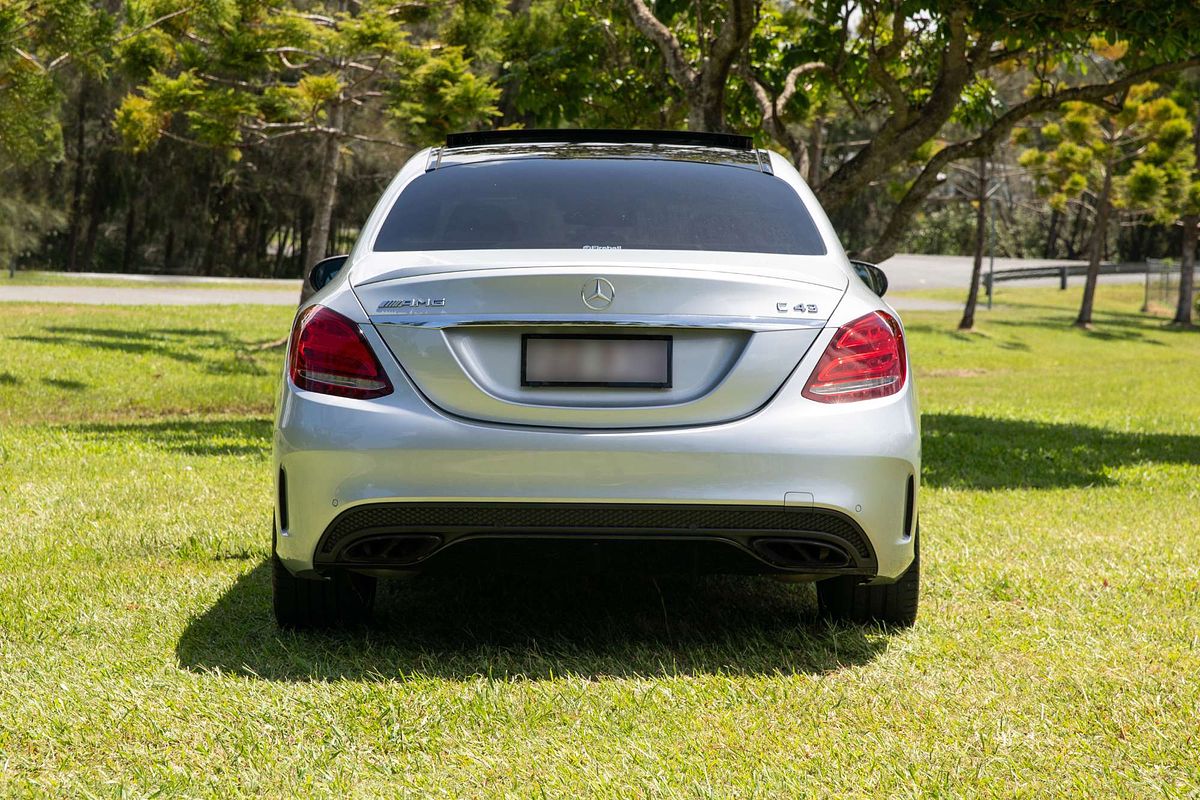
[288,306,391,399]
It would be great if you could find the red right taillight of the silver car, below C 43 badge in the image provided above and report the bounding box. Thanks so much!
[804,311,908,403]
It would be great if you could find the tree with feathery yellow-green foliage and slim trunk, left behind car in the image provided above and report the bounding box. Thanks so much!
[116,0,498,300]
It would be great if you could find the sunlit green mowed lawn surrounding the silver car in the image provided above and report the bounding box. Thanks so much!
[0,287,1200,798]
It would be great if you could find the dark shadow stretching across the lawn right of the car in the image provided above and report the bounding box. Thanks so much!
[920,414,1200,489]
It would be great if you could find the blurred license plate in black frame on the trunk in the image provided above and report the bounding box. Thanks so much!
[521,333,671,389]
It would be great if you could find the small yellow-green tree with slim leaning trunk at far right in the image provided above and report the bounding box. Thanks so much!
[1021,83,1194,327]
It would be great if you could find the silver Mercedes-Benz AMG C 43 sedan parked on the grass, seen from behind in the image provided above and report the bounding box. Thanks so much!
[272,131,920,627]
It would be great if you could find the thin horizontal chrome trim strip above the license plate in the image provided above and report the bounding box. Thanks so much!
[371,309,824,331]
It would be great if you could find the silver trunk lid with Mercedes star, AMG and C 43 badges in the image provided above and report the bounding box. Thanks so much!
[352,256,846,428]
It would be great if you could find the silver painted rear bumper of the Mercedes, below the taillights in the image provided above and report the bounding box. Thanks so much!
[275,352,920,581]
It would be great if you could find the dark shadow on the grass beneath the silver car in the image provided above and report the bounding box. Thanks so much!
[175,563,890,681]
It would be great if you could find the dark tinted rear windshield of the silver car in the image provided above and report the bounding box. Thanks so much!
[374,158,826,255]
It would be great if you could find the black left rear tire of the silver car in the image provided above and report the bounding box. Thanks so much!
[271,537,377,630]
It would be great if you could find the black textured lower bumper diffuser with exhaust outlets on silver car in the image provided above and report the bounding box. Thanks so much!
[313,503,877,577]
